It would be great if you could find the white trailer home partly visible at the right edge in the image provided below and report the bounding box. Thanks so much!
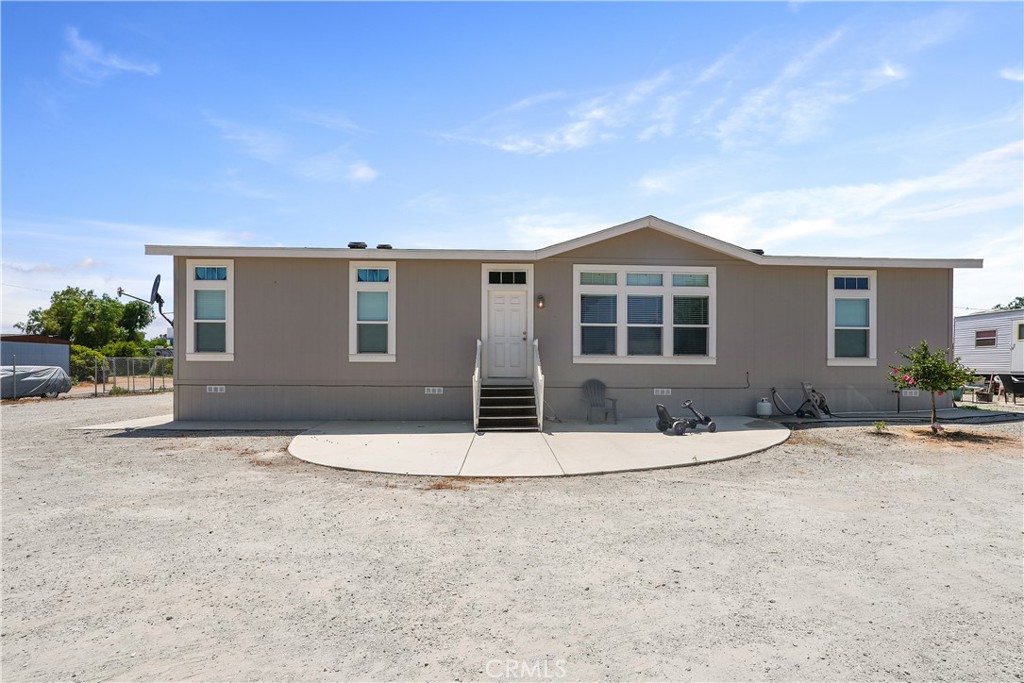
[953,308,1024,376]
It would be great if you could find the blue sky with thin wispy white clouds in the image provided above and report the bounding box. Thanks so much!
[0,2,1024,333]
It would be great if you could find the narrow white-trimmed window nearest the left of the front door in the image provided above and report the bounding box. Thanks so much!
[348,261,395,362]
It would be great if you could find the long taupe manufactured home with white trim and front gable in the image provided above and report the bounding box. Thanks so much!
[146,216,982,428]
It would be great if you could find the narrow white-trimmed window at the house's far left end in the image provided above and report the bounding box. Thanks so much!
[185,259,234,360]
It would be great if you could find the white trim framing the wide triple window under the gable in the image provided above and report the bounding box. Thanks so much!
[571,263,718,366]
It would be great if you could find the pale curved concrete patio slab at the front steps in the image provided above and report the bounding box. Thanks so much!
[288,416,790,477]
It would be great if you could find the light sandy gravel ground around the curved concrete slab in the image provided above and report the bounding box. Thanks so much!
[0,394,1024,681]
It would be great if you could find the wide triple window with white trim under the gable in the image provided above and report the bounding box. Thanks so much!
[572,265,716,365]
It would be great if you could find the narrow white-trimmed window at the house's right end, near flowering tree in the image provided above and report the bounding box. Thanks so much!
[828,270,878,366]
